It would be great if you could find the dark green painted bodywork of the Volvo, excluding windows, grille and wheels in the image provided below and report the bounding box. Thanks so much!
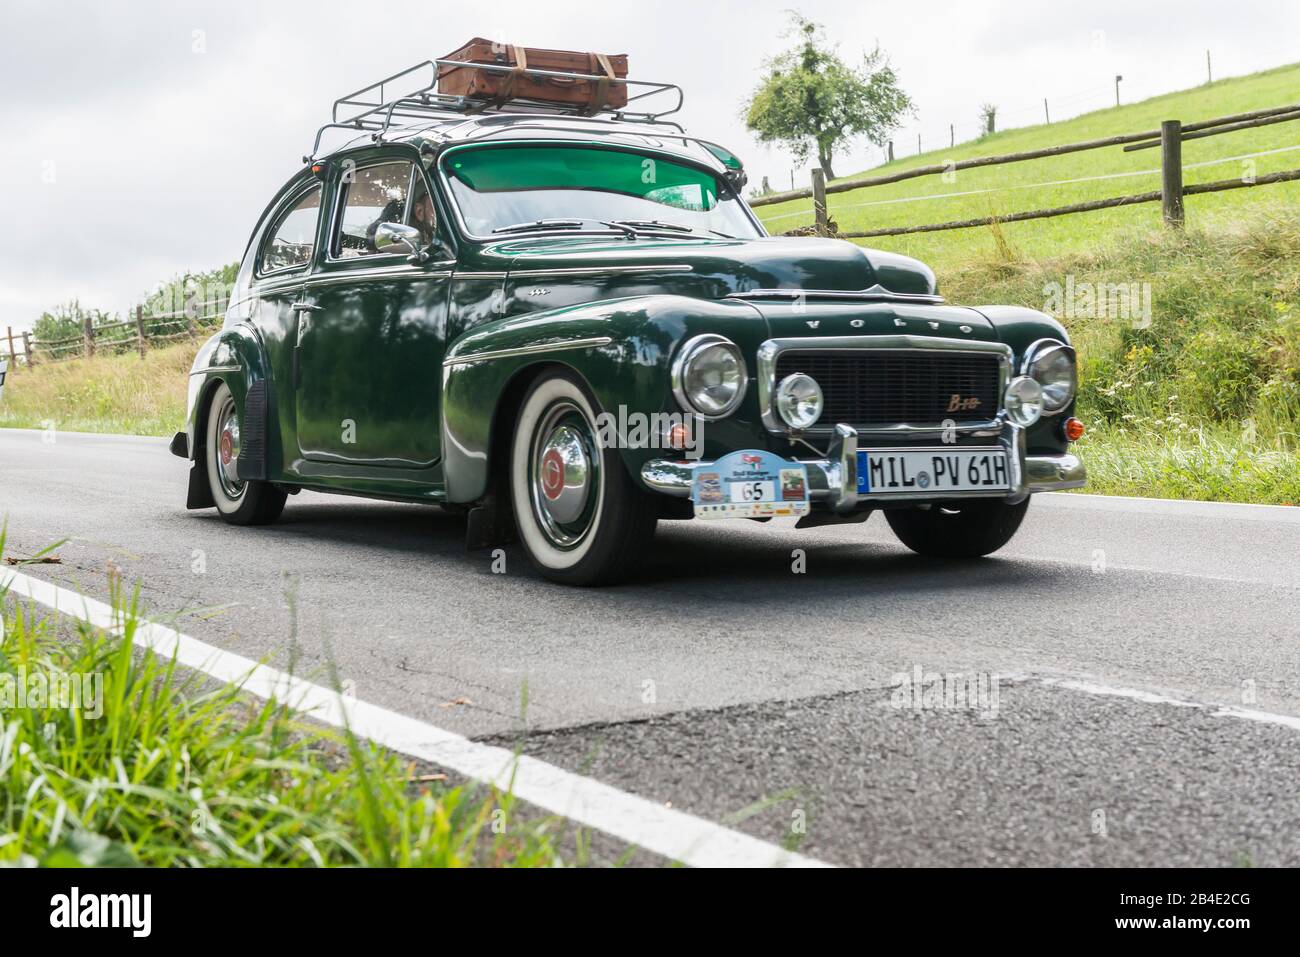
[174,113,1083,561]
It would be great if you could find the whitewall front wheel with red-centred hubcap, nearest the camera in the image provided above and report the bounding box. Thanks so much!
[510,372,657,585]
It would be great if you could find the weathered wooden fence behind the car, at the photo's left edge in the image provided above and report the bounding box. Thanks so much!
[0,299,225,373]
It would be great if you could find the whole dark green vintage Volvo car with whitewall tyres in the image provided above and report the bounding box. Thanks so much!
[172,61,1084,584]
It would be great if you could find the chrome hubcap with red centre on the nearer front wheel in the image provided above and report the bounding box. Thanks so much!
[529,402,601,547]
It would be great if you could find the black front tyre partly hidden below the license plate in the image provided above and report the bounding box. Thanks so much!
[885,498,1030,558]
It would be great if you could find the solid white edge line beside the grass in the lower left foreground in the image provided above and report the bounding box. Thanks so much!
[0,570,829,867]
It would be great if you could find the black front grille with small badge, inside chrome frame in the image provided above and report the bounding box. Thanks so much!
[774,348,1000,428]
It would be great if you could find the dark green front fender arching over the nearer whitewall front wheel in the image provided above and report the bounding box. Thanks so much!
[442,295,767,502]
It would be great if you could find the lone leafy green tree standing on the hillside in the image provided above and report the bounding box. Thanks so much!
[745,13,913,179]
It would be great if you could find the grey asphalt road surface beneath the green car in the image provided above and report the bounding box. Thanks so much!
[0,430,1300,866]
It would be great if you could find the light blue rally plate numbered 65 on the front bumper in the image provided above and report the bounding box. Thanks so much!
[690,449,809,519]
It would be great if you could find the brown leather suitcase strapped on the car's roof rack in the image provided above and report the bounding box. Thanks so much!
[438,36,628,114]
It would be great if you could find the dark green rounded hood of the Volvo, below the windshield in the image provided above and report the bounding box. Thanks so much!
[490,237,935,298]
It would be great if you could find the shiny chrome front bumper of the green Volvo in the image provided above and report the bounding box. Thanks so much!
[641,424,1087,512]
